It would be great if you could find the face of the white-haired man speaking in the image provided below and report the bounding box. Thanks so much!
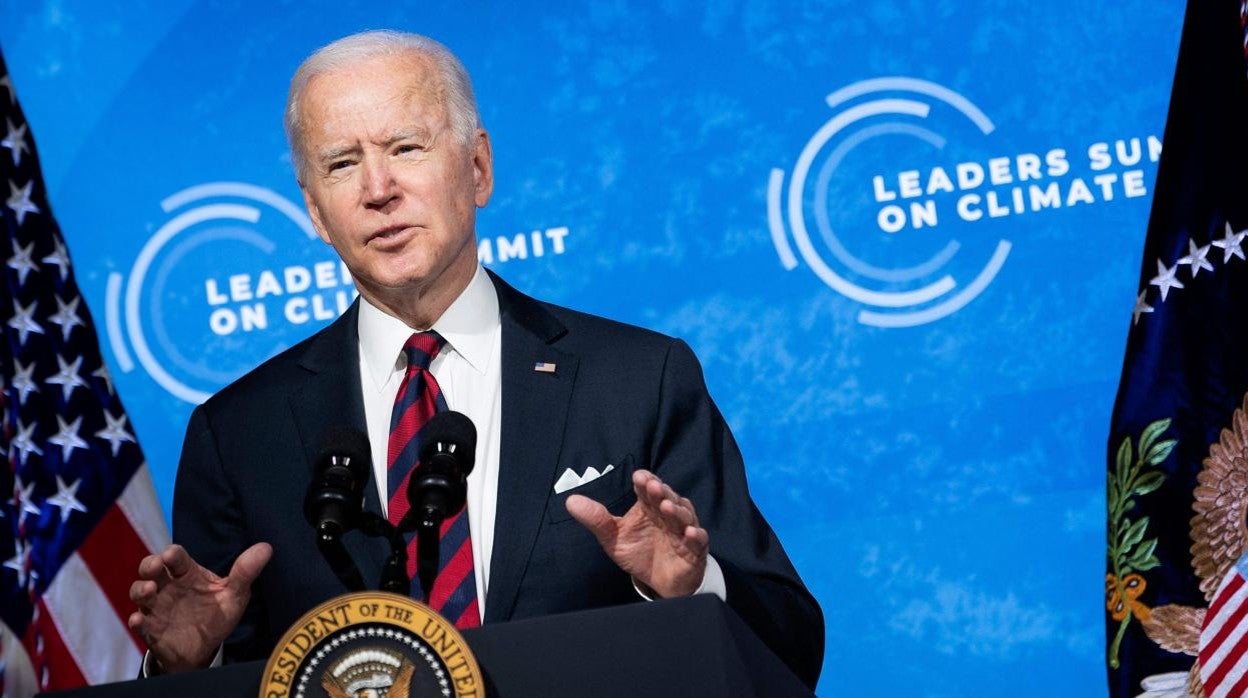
[300,52,493,315]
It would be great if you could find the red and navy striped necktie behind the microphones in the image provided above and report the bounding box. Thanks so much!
[387,330,480,628]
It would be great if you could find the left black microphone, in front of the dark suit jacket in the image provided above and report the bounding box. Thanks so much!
[303,426,372,547]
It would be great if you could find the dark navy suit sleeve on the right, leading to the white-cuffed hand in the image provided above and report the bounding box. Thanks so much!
[650,341,824,687]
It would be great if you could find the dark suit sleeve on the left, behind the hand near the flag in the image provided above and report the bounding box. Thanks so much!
[173,406,267,662]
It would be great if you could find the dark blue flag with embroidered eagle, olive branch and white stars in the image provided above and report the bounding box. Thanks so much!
[1104,0,1248,698]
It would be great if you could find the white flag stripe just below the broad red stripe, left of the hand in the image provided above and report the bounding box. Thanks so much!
[44,554,142,684]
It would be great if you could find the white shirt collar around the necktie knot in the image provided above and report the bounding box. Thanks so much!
[358,265,499,391]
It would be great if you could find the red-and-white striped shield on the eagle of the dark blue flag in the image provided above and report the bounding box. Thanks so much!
[1197,556,1248,698]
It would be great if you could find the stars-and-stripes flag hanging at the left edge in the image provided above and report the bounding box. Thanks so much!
[0,47,168,698]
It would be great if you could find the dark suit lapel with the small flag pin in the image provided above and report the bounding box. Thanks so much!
[485,273,578,623]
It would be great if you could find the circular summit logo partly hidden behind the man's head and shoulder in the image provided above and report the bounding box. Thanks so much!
[105,182,356,405]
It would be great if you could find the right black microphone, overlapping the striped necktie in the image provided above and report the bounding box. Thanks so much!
[399,412,477,598]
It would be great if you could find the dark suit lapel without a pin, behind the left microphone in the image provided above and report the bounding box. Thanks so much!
[290,301,389,588]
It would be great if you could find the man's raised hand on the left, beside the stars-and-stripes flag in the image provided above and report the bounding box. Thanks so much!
[130,543,273,673]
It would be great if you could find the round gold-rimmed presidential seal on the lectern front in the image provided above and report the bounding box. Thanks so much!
[260,592,485,698]
